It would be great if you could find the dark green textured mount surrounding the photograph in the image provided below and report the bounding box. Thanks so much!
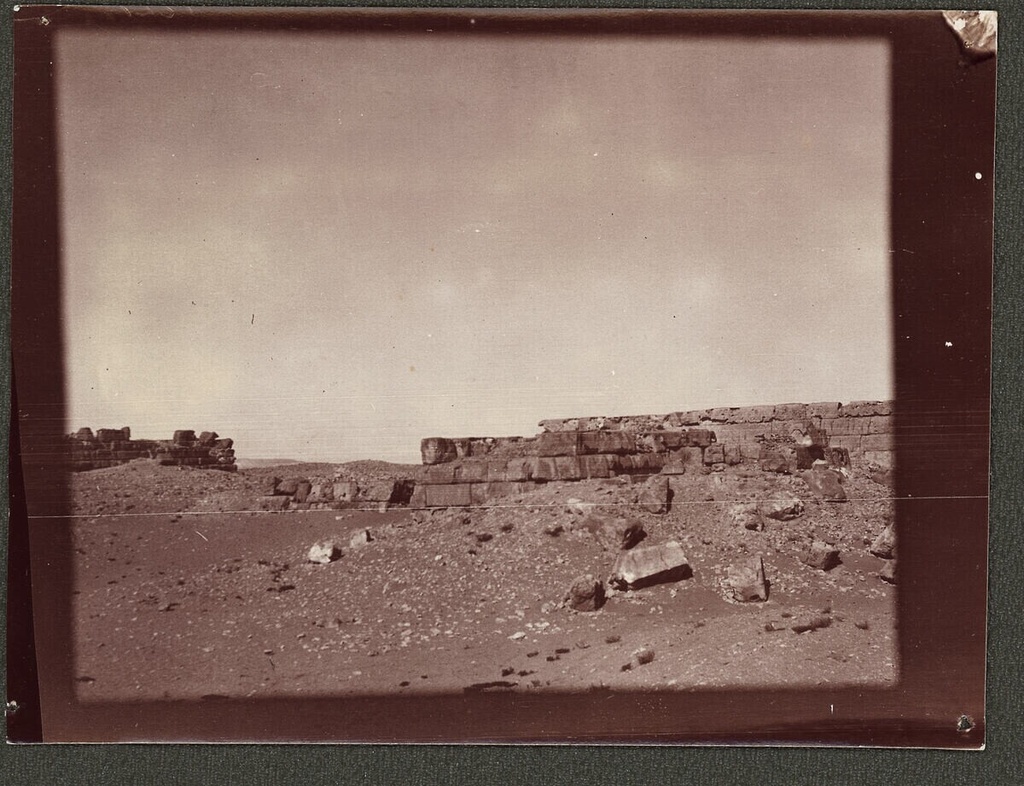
[0,0,1024,786]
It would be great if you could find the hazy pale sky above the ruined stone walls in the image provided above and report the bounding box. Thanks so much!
[56,24,893,463]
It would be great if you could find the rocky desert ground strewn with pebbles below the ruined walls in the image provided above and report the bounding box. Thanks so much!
[71,460,898,702]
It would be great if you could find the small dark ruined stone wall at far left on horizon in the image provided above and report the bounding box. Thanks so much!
[67,426,238,472]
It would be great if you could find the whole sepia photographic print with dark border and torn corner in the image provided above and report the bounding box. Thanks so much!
[8,6,995,747]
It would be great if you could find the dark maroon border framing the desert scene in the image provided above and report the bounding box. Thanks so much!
[8,6,996,748]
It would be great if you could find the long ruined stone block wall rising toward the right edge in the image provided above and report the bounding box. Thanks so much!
[410,401,894,508]
